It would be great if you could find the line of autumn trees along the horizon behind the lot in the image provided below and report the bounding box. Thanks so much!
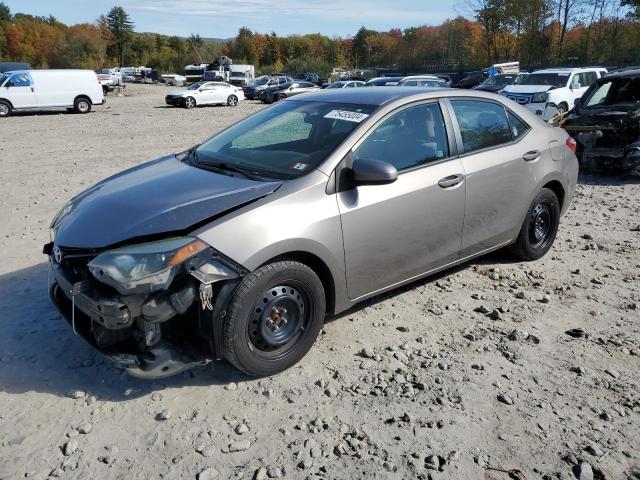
[0,0,640,75]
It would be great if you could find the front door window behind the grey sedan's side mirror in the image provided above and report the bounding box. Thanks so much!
[353,103,449,171]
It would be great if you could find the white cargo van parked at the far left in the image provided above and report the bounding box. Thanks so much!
[0,70,104,117]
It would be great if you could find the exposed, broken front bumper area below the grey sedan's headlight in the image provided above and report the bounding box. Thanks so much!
[49,248,246,379]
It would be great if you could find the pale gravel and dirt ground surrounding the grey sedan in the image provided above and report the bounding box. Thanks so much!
[0,86,640,480]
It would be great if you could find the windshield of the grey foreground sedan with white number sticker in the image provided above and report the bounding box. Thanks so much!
[196,101,376,180]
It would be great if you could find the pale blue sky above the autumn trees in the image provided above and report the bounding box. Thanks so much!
[1,0,460,38]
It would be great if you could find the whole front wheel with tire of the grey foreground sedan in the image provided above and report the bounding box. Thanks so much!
[222,261,326,377]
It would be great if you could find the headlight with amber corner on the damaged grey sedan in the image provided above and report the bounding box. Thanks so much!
[88,237,209,294]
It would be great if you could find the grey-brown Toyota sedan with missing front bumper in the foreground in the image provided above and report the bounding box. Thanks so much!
[44,87,578,378]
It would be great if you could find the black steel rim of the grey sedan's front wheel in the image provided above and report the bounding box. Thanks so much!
[248,284,308,352]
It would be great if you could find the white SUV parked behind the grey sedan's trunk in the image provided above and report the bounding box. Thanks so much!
[500,67,607,120]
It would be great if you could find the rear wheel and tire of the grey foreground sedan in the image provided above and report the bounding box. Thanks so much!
[511,188,560,260]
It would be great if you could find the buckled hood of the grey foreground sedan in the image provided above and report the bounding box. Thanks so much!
[51,155,282,249]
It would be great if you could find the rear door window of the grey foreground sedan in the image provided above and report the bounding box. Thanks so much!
[451,100,513,153]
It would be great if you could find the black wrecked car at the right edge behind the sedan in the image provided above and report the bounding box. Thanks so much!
[563,68,640,174]
